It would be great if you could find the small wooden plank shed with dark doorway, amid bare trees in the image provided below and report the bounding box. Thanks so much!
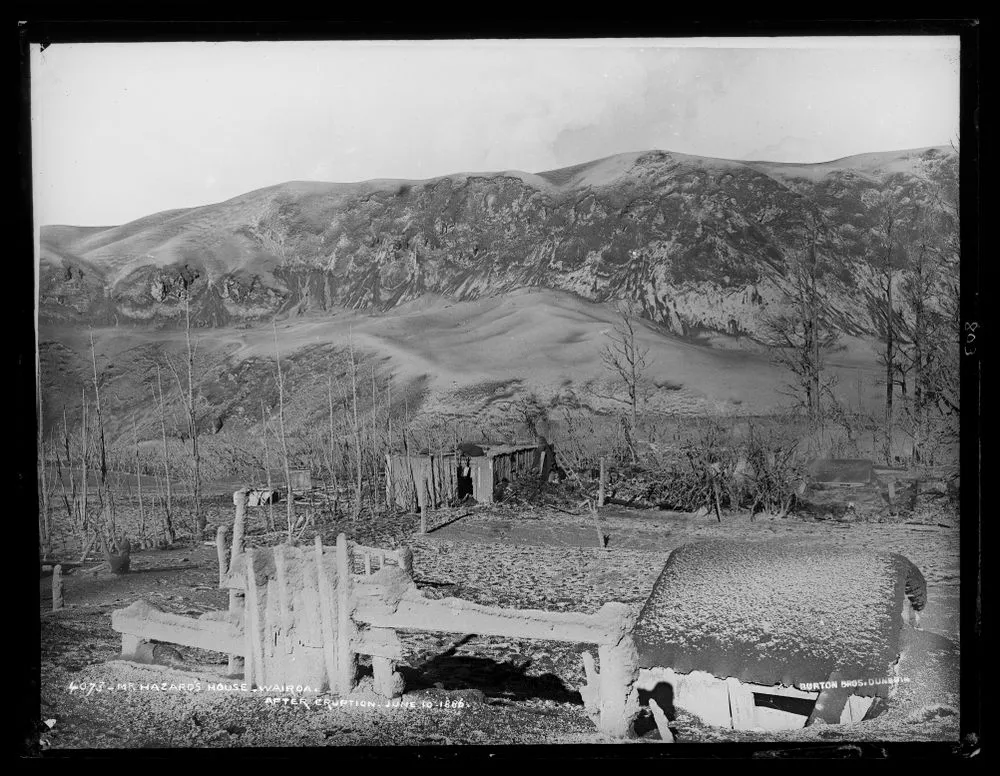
[385,442,553,509]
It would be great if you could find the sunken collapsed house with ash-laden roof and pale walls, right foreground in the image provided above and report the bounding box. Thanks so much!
[634,541,926,730]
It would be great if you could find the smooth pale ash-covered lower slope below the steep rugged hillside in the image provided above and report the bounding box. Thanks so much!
[41,290,892,458]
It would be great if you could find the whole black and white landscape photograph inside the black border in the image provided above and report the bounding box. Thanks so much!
[21,26,981,757]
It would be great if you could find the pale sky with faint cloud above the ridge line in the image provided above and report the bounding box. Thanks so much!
[30,36,959,226]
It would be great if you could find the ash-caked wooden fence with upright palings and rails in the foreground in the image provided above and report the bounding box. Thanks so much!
[112,491,638,737]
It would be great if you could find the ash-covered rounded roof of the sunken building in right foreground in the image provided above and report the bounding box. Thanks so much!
[635,541,923,694]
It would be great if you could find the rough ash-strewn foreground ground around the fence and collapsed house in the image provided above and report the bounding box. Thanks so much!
[38,492,960,751]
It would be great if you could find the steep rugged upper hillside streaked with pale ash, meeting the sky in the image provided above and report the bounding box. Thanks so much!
[40,148,957,336]
